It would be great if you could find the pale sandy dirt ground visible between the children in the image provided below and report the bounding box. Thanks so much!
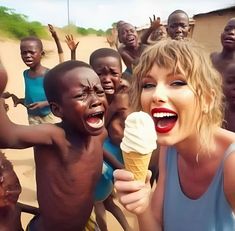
[0,36,138,231]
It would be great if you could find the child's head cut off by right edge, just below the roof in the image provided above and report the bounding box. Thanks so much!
[221,18,235,51]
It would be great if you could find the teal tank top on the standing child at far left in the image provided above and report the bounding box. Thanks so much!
[23,70,51,116]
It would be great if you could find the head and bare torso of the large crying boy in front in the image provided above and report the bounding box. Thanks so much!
[30,61,107,231]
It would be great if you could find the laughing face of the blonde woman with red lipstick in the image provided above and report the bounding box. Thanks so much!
[140,64,200,145]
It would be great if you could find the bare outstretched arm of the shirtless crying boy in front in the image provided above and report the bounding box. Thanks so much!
[0,99,69,155]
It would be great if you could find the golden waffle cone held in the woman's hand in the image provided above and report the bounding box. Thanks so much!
[122,151,152,181]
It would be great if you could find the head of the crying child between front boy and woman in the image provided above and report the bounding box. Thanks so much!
[90,48,122,102]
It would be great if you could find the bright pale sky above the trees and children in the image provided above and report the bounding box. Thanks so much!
[0,0,235,30]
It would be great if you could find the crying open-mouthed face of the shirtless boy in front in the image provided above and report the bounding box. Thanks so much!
[58,67,108,135]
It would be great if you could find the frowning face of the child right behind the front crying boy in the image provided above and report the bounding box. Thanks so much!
[93,56,121,96]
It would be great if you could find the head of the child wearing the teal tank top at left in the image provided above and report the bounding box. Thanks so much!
[20,36,45,68]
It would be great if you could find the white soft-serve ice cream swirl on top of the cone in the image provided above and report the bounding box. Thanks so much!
[121,111,157,155]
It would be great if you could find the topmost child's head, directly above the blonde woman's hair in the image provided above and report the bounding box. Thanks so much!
[167,10,190,40]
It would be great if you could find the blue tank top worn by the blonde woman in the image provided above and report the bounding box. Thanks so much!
[163,143,235,231]
